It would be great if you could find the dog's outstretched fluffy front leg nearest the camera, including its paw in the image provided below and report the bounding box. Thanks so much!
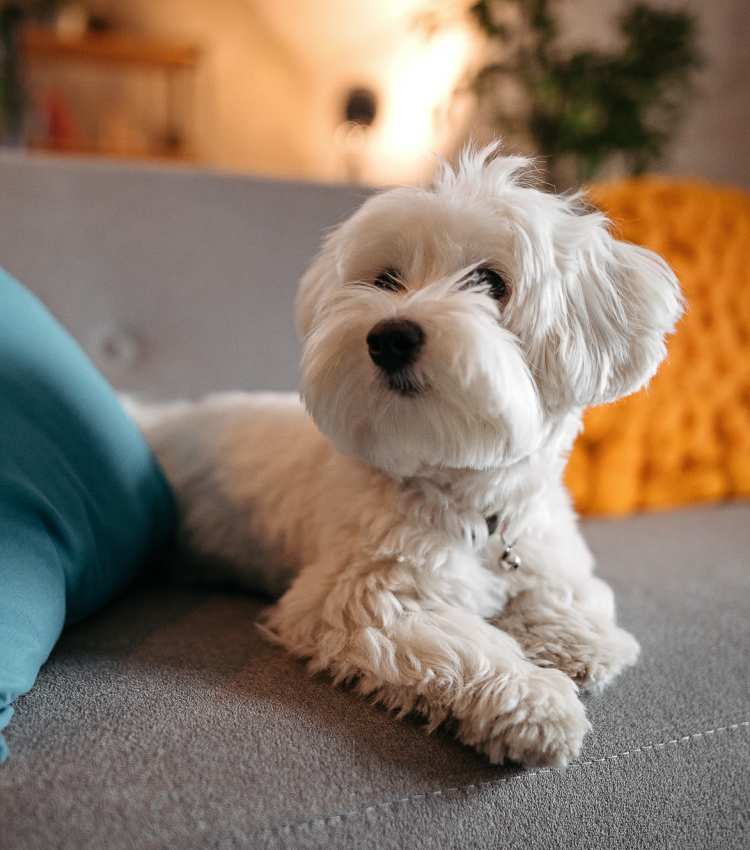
[266,567,589,766]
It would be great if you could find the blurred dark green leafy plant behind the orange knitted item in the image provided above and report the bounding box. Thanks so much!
[469,0,701,181]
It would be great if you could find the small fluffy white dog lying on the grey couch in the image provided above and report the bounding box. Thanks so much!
[134,146,682,766]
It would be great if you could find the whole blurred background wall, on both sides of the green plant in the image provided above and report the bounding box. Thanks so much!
[86,0,750,186]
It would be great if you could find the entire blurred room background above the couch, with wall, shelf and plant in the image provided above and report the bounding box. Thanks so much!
[0,0,750,187]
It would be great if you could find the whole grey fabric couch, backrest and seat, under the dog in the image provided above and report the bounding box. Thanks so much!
[0,156,750,850]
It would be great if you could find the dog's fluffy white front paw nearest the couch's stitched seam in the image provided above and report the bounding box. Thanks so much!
[459,668,590,767]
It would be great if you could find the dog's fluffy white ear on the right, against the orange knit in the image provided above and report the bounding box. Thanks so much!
[538,209,683,406]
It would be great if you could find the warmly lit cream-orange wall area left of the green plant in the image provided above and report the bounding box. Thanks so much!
[86,0,476,182]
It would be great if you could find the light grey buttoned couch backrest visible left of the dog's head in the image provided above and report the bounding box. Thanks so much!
[0,154,365,397]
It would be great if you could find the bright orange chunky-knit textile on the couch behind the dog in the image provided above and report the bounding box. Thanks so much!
[567,177,750,514]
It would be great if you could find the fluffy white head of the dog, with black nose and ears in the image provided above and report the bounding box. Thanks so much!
[297,146,682,475]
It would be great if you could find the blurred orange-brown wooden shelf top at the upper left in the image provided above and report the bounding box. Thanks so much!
[22,27,200,70]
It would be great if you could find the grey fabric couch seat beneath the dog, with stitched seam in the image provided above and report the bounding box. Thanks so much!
[0,504,750,850]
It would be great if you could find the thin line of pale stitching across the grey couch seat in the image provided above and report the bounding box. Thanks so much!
[261,720,750,836]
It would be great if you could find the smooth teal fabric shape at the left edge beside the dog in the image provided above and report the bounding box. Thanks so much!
[0,269,175,761]
